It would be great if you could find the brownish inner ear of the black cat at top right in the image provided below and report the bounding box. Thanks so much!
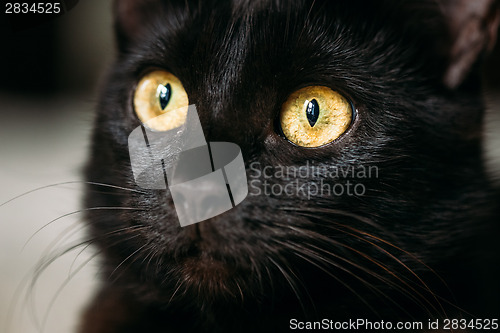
[439,0,500,89]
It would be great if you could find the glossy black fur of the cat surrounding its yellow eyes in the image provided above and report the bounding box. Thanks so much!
[82,0,499,332]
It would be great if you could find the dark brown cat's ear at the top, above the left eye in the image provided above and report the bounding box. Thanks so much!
[113,0,160,50]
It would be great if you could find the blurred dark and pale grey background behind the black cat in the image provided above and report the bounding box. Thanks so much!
[0,0,500,333]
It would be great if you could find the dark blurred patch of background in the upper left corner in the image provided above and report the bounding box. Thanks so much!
[0,0,113,97]
